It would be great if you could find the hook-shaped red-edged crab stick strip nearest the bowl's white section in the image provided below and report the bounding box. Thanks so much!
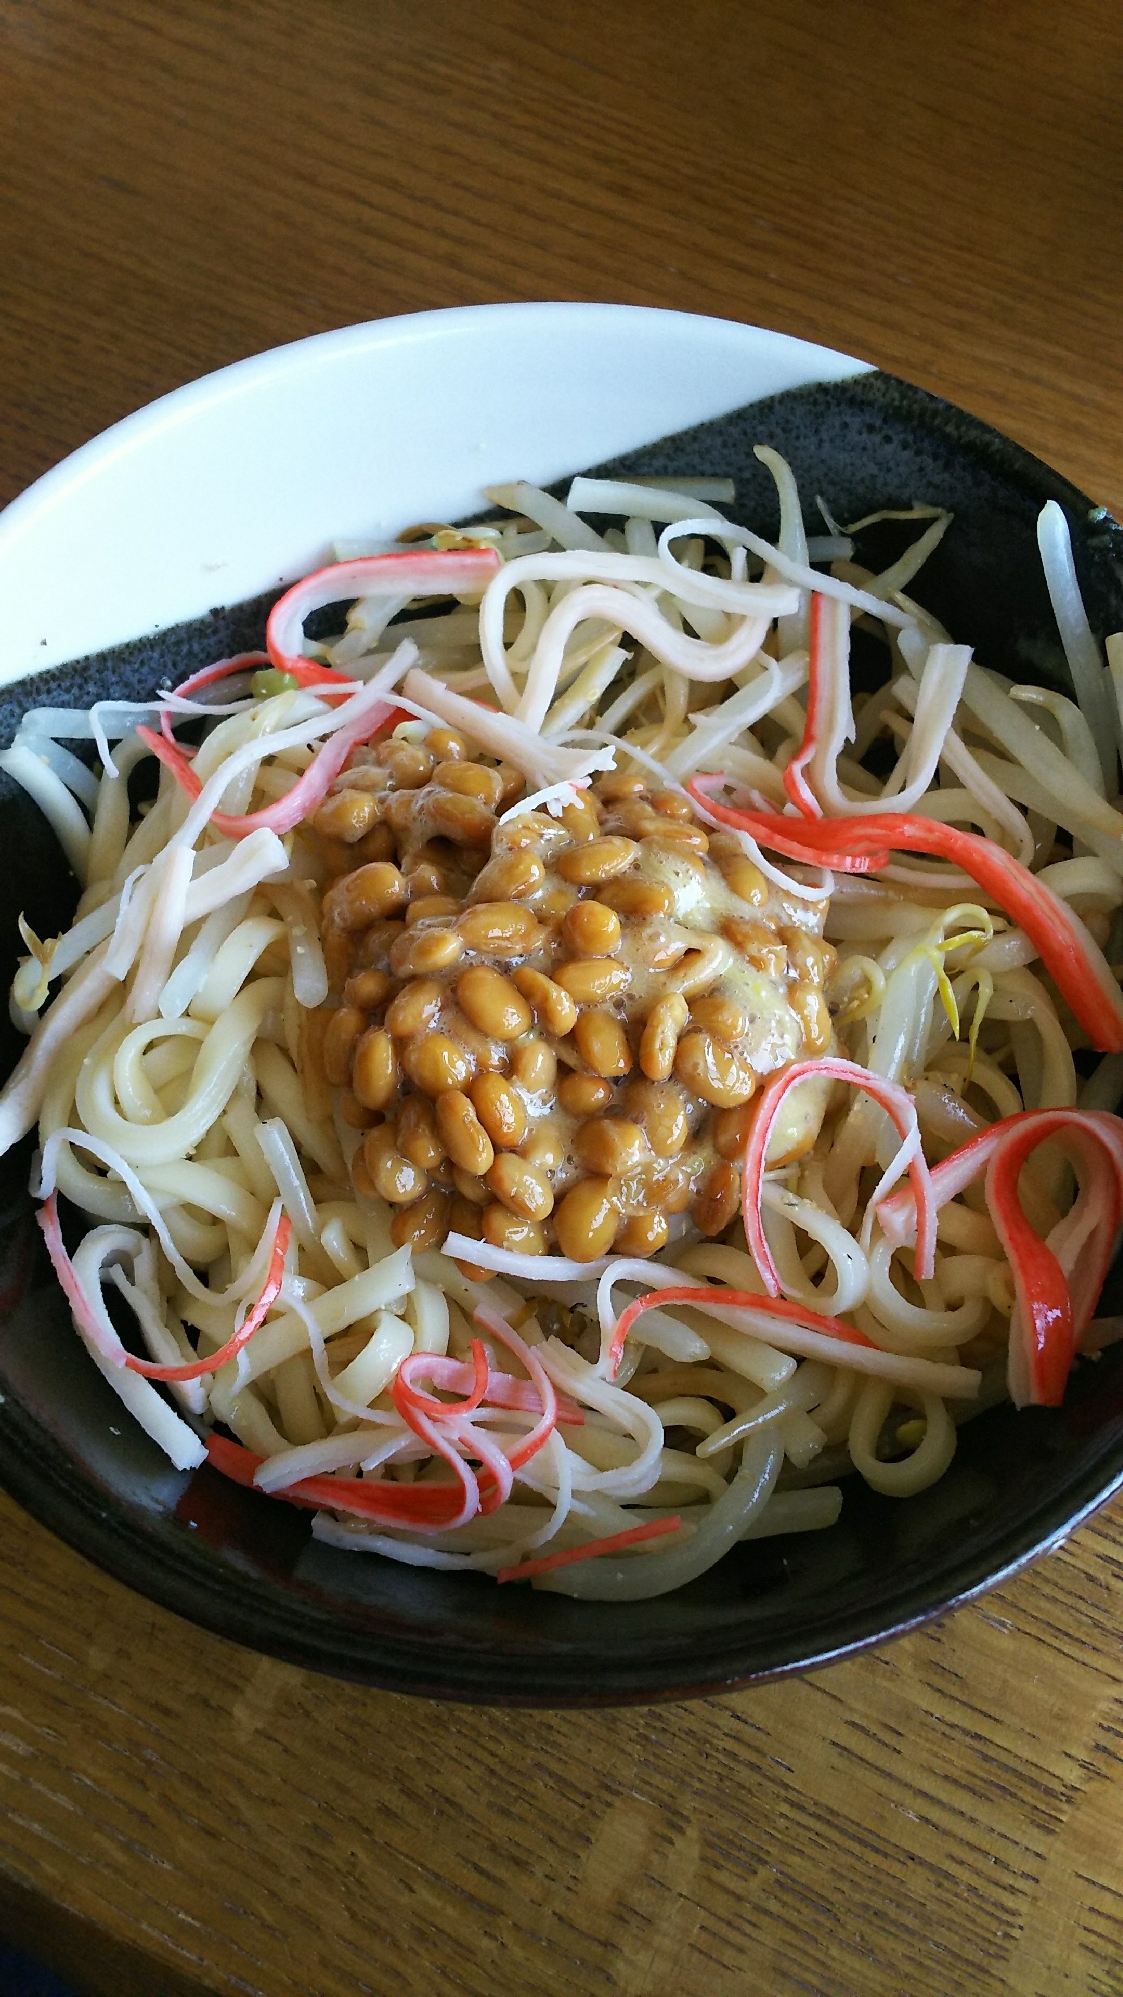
[266,547,500,687]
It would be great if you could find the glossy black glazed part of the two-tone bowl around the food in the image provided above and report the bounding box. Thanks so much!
[0,373,1123,1705]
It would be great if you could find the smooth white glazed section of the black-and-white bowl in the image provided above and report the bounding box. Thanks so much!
[0,300,871,687]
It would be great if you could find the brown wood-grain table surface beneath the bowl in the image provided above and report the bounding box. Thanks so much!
[0,0,1123,1997]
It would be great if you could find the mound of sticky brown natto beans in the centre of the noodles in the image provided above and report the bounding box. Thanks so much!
[312,729,833,1276]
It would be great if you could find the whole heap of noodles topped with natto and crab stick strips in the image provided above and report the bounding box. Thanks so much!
[0,459,1123,1600]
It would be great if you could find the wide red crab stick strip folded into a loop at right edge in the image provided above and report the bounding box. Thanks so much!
[877,1108,1123,1408]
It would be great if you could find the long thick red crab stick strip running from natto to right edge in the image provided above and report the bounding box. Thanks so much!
[687,777,1123,1054]
